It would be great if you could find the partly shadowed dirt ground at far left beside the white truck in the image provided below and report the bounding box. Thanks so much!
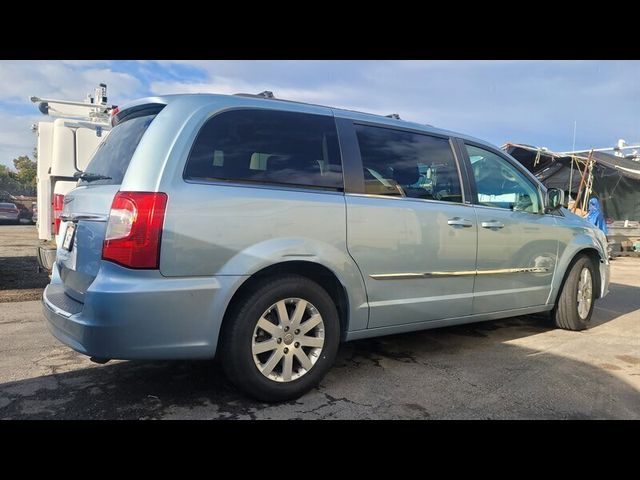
[0,224,49,303]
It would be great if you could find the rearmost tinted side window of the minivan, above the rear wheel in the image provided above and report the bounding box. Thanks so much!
[184,109,343,189]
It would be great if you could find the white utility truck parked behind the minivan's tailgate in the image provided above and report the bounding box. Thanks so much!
[31,83,117,271]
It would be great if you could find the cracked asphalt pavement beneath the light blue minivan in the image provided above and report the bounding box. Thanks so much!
[0,227,640,419]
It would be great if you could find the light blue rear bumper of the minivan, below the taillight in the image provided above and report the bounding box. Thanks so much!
[42,262,245,360]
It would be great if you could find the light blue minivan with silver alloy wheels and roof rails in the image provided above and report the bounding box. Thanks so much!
[43,93,609,401]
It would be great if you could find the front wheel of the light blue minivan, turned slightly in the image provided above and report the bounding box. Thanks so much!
[553,256,595,330]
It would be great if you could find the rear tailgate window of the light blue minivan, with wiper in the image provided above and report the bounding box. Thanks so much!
[80,107,159,185]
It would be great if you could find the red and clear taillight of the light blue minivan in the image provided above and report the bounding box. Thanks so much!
[102,192,167,269]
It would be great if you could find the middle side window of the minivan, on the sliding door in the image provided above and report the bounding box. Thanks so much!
[354,125,462,202]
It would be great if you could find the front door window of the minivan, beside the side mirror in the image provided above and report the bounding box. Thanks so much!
[465,145,541,213]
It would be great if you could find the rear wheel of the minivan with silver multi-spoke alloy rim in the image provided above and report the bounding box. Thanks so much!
[221,275,340,402]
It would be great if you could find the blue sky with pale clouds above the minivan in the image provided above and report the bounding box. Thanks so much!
[0,60,640,165]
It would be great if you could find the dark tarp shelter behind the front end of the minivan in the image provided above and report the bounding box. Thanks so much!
[505,144,640,221]
